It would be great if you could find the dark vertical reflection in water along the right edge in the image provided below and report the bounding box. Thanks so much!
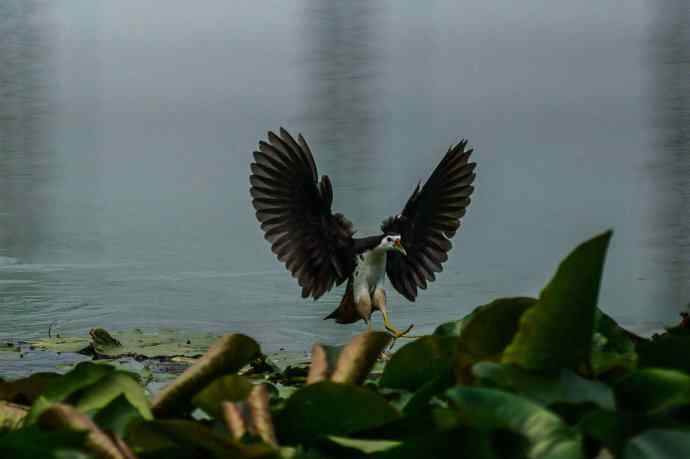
[652,0,690,312]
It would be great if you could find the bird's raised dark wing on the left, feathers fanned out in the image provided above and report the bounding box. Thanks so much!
[249,128,354,299]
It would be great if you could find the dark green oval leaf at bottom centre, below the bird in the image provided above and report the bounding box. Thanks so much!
[277,381,400,444]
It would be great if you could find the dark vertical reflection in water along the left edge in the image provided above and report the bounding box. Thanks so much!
[0,0,53,262]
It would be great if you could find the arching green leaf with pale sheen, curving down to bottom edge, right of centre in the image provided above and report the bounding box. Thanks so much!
[446,387,584,459]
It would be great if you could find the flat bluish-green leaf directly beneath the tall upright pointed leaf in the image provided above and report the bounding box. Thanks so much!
[472,362,615,409]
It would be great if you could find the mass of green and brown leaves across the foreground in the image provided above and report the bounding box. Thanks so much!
[0,232,690,459]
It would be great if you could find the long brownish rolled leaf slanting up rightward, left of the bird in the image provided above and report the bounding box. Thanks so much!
[153,334,260,418]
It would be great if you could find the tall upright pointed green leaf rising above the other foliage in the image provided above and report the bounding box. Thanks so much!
[502,231,611,370]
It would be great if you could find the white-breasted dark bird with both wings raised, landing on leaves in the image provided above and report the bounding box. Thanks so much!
[249,127,476,338]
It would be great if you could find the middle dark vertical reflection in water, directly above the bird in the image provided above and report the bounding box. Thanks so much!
[302,0,380,226]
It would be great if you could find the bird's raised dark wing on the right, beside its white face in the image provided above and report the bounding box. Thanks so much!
[381,140,476,301]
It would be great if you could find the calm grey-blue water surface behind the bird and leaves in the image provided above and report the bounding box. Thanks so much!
[0,0,690,362]
